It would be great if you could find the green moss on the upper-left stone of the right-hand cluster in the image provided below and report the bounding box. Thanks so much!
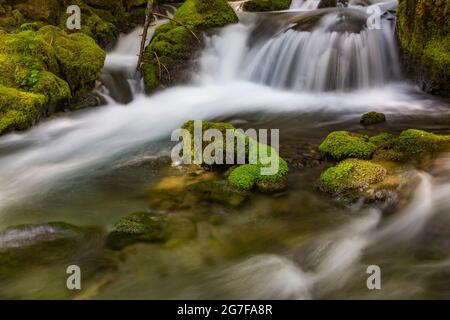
[319,131,376,160]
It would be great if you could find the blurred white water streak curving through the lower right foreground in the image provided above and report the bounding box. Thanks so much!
[218,170,450,299]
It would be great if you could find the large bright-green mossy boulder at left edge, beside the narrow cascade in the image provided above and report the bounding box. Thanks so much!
[0,26,105,134]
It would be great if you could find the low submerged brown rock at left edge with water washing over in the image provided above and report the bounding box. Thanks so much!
[0,222,113,280]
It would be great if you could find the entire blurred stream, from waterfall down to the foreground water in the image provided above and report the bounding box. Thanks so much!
[0,1,450,299]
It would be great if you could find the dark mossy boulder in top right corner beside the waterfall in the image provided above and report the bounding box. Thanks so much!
[397,0,450,96]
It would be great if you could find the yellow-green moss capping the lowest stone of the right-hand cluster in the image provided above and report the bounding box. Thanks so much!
[320,159,387,193]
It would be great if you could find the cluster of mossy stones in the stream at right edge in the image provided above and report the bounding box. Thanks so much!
[319,129,450,209]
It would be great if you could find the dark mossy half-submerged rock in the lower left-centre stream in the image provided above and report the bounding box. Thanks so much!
[106,212,196,250]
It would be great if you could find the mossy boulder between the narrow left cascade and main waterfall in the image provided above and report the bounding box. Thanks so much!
[142,0,238,92]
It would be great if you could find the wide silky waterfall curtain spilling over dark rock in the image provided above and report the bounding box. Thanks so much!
[243,9,400,91]
